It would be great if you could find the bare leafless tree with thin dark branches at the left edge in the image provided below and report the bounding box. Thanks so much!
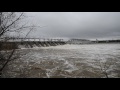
[0,12,35,76]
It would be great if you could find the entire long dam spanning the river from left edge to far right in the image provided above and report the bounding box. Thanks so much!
[0,37,120,50]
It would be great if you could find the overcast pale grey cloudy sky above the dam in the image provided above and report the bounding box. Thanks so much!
[21,12,120,39]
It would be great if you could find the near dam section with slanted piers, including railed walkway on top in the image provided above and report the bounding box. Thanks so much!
[0,38,66,50]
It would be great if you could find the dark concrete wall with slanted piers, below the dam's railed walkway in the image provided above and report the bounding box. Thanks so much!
[0,41,66,50]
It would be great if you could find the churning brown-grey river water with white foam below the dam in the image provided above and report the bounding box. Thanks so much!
[3,44,120,78]
